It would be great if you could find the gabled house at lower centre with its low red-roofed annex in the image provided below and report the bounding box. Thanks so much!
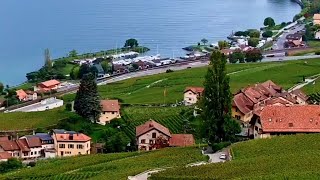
[136,120,195,151]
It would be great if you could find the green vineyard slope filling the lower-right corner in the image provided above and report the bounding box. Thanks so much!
[151,134,320,180]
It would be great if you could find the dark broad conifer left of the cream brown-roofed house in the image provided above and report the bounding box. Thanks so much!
[74,73,101,122]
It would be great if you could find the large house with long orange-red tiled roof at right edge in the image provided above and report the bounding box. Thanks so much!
[249,105,320,138]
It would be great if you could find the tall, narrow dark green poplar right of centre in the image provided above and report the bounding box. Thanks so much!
[200,51,240,146]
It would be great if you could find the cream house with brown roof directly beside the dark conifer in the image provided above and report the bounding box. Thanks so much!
[97,100,121,125]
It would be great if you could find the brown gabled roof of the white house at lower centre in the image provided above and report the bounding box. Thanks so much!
[136,120,171,137]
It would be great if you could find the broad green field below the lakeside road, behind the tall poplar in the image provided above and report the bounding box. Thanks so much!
[94,59,320,104]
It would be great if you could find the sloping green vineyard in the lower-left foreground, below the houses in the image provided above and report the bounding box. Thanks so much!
[0,147,207,180]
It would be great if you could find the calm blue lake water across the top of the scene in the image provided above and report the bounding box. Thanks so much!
[0,0,300,85]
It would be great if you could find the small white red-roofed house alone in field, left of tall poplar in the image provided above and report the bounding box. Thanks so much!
[183,87,204,106]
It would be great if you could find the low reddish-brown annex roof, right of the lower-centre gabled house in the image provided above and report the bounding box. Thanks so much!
[169,134,195,147]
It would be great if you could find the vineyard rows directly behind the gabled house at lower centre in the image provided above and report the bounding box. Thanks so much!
[122,107,188,137]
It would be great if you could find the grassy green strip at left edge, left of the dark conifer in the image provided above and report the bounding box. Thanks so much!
[0,107,76,131]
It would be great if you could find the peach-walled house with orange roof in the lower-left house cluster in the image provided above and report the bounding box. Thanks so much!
[52,129,91,157]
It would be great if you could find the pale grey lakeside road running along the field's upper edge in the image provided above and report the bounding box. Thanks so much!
[98,55,320,85]
